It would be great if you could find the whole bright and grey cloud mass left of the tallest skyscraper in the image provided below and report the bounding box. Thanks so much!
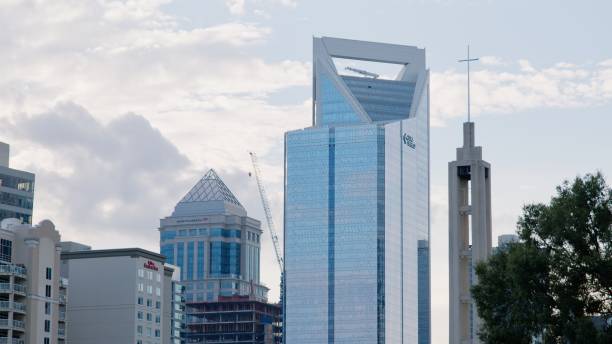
[0,0,311,302]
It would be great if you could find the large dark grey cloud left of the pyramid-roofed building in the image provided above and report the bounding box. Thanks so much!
[2,103,193,246]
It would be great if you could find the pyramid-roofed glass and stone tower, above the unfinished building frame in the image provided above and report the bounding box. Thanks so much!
[160,170,268,303]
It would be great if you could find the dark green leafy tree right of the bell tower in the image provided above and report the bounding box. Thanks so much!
[472,173,612,344]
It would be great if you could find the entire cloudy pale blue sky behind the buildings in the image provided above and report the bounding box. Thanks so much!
[0,0,612,343]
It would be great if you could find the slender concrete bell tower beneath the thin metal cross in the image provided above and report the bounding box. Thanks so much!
[448,121,491,344]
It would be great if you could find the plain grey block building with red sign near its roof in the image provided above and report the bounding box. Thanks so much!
[61,248,182,344]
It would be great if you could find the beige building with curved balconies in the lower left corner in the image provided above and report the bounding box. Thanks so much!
[0,219,62,344]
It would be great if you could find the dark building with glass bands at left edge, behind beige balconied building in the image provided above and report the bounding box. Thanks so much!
[0,142,35,224]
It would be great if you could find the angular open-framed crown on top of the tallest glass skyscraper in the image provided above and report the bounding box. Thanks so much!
[313,37,428,127]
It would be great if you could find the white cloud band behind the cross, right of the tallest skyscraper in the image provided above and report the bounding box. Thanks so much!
[432,58,612,125]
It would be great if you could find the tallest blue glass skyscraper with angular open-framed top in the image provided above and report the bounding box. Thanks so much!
[283,37,431,344]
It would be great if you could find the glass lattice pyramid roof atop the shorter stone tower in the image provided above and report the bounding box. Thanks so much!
[172,169,246,216]
